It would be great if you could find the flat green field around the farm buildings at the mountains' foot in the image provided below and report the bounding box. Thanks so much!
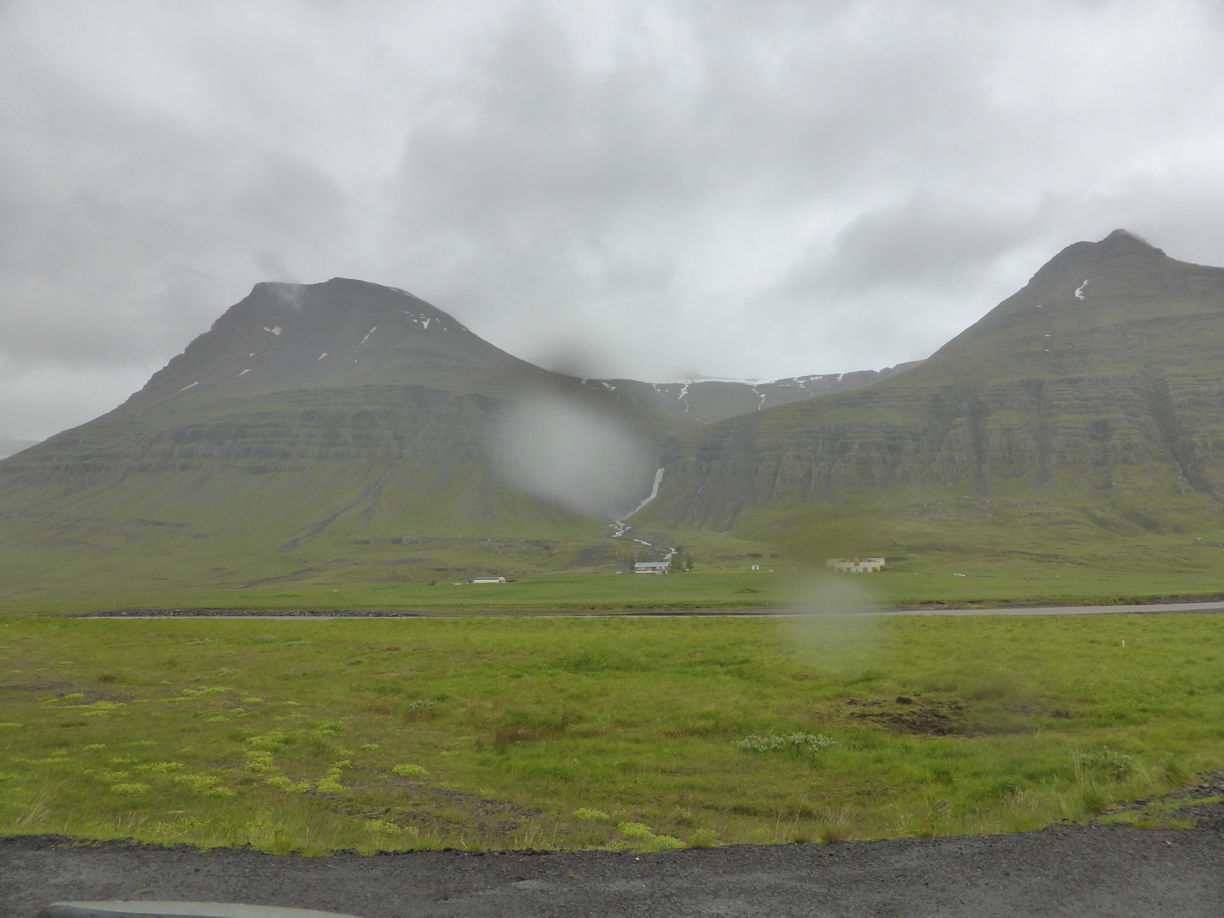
[0,550,1224,614]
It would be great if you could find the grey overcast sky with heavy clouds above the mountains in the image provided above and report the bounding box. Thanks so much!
[0,0,1224,438]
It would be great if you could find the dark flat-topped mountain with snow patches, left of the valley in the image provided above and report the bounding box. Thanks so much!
[0,279,621,597]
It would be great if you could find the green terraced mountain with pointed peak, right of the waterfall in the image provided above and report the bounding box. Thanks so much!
[646,230,1224,545]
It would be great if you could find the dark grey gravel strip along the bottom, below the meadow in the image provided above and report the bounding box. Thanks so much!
[0,803,1224,918]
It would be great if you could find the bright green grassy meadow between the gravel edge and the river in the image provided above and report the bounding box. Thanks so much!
[0,612,1224,853]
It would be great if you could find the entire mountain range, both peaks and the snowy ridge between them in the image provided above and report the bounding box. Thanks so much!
[0,230,1224,602]
